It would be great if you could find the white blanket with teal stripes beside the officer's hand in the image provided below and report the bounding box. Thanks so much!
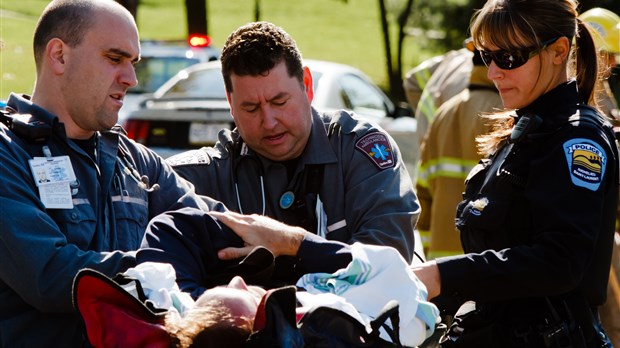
[297,243,440,347]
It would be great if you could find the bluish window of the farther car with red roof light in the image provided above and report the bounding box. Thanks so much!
[128,57,199,93]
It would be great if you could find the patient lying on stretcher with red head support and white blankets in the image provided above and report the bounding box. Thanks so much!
[74,210,439,348]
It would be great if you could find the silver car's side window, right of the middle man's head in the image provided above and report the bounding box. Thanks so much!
[339,74,386,117]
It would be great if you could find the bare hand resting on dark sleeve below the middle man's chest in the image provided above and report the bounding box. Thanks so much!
[209,211,308,260]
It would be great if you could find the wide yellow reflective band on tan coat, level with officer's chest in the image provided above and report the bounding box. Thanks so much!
[417,157,478,187]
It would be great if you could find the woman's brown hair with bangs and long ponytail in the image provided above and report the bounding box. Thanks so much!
[471,0,600,154]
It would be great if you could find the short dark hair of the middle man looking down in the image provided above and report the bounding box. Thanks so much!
[221,22,304,93]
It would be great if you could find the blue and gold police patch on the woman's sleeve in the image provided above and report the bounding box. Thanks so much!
[563,138,607,191]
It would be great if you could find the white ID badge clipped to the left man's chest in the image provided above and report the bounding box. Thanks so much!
[28,156,75,209]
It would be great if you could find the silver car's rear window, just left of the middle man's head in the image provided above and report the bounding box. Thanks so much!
[162,69,226,99]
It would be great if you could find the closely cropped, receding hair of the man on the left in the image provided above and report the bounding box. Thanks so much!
[33,0,98,67]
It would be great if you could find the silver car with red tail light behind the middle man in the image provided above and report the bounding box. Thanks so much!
[124,60,416,170]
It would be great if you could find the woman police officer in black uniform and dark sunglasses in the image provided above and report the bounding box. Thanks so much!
[415,0,618,347]
